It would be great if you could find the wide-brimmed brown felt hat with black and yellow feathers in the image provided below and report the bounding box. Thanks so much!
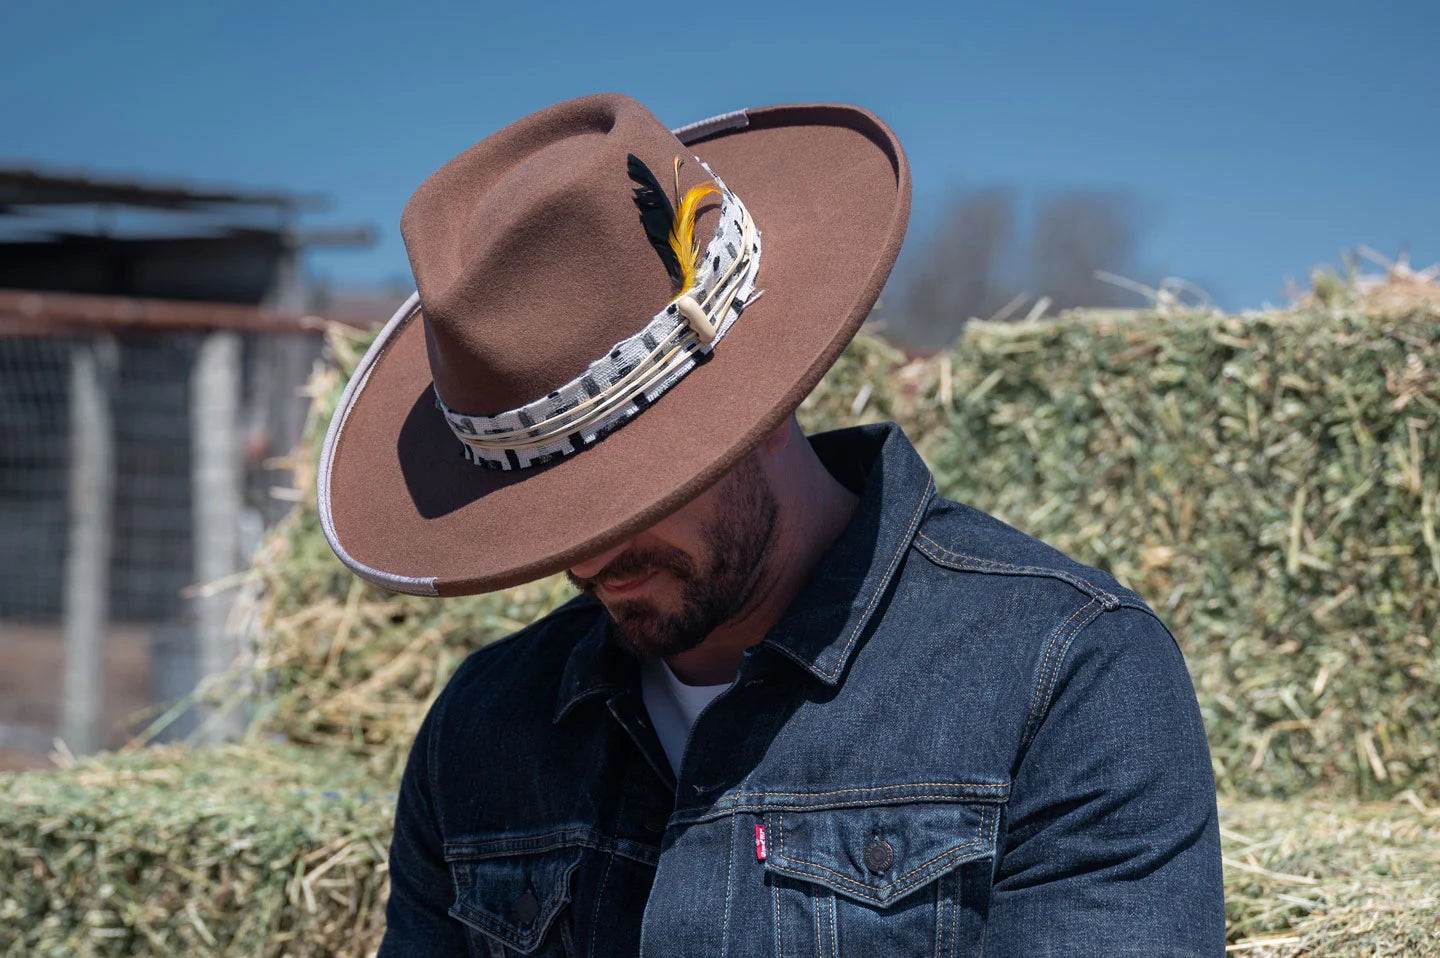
[318,95,910,595]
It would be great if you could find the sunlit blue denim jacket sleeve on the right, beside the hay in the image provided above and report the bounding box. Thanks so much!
[984,605,1225,958]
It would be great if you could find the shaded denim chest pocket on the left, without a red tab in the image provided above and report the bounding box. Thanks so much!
[445,836,586,958]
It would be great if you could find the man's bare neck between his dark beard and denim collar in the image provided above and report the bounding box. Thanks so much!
[665,429,860,686]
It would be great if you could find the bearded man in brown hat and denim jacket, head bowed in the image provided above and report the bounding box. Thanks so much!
[318,97,1224,958]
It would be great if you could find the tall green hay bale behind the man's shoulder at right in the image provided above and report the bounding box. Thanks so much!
[930,308,1440,800]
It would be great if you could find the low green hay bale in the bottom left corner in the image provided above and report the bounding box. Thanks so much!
[0,746,395,957]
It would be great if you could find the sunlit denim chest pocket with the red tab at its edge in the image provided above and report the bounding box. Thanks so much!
[763,801,999,958]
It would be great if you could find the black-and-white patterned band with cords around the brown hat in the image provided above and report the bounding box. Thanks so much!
[435,164,760,470]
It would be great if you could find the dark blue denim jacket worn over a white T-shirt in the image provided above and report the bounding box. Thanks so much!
[380,424,1224,958]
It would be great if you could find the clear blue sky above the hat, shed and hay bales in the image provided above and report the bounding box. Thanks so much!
[0,0,1440,308]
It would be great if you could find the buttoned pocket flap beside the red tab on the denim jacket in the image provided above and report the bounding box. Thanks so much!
[765,802,999,908]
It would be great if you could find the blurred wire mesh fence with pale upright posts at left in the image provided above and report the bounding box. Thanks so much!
[0,304,321,765]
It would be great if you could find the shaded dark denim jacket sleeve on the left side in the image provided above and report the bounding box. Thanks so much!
[379,694,468,958]
